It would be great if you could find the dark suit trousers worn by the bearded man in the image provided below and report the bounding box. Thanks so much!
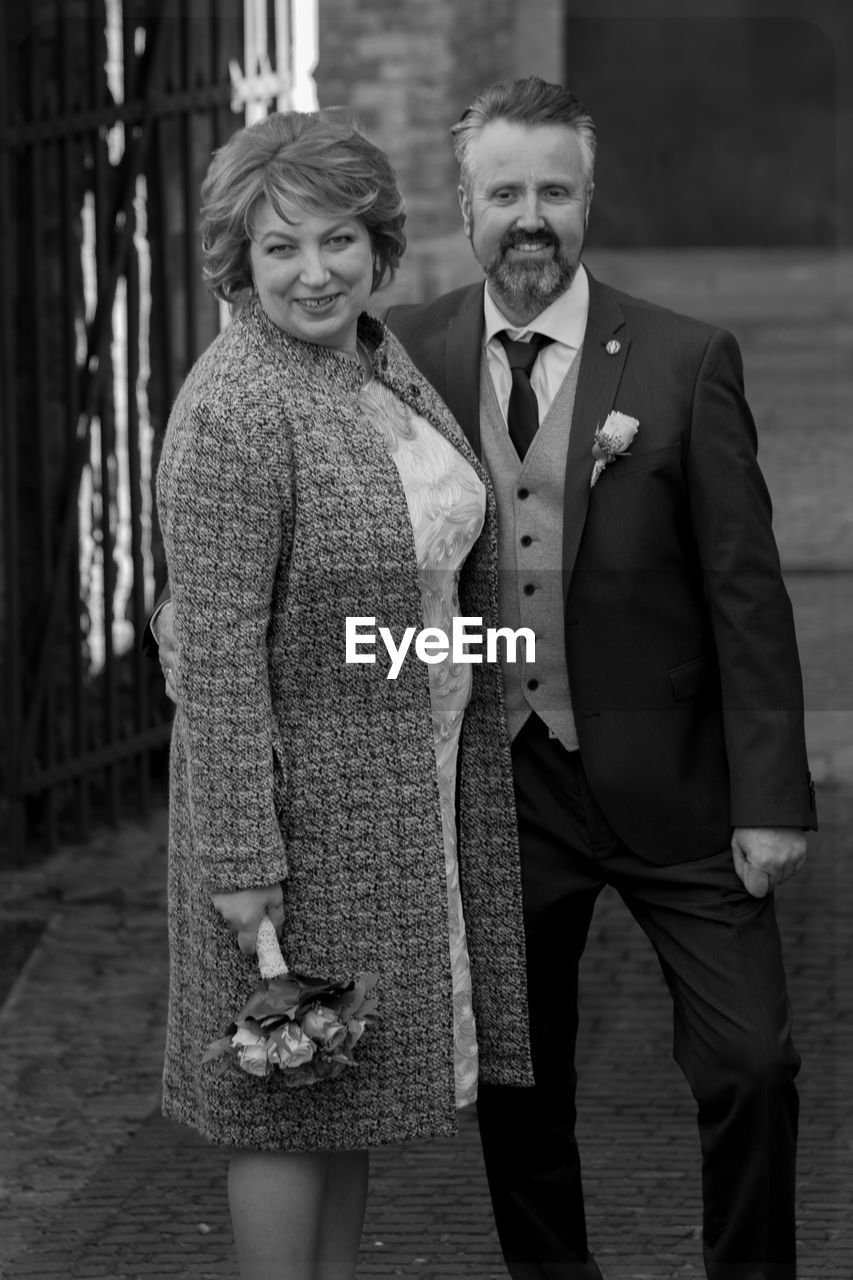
[478,716,799,1280]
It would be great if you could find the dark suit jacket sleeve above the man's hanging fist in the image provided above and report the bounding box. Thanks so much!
[686,330,816,828]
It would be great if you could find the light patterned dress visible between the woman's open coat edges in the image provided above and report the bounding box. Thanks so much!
[359,379,485,1107]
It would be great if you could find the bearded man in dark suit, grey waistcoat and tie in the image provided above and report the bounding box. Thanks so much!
[149,78,816,1280]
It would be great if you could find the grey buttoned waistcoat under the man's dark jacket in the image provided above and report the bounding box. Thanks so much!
[480,351,581,751]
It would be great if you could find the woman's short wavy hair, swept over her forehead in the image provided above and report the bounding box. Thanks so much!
[201,108,406,302]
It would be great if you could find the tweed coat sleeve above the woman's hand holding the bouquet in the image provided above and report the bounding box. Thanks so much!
[158,407,287,892]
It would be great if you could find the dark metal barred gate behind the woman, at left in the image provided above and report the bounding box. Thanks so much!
[0,0,314,856]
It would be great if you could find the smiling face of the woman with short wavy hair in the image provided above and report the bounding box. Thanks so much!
[248,200,373,355]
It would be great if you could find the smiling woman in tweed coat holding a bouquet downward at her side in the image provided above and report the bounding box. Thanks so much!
[151,111,532,1280]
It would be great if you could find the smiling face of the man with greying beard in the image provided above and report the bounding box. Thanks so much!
[459,120,592,323]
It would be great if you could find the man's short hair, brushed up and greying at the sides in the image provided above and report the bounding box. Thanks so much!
[451,76,596,191]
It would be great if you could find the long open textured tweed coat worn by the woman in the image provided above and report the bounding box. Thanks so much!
[158,301,532,1151]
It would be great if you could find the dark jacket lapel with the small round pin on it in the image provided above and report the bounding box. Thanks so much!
[562,271,630,595]
